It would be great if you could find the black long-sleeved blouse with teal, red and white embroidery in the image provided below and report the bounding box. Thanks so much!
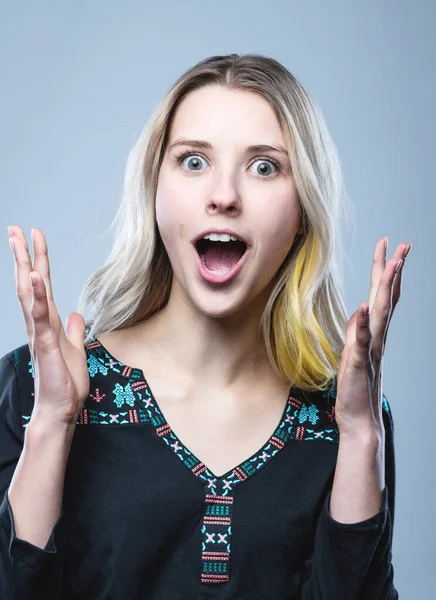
[0,338,398,600]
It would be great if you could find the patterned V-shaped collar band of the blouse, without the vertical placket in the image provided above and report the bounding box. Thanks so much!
[86,329,303,496]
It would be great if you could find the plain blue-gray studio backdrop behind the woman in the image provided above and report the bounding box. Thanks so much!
[0,0,436,600]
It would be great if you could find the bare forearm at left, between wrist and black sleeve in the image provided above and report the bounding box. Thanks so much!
[8,420,74,548]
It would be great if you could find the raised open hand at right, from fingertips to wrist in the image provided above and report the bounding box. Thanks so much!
[335,238,412,435]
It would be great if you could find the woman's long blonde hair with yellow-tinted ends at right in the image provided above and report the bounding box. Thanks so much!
[78,54,350,390]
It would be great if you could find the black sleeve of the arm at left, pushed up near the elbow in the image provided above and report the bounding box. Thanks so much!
[0,353,62,600]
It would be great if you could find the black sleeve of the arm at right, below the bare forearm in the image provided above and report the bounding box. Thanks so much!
[301,395,398,600]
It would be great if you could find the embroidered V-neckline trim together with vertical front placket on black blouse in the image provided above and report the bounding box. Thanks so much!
[81,328,328,585]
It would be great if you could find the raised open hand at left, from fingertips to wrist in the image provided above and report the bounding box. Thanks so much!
[9,225,90,426]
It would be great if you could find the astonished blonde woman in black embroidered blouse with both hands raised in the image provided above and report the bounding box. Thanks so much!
[0,54,411,600]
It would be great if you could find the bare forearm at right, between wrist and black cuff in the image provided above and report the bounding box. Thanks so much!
[330,431,385,523]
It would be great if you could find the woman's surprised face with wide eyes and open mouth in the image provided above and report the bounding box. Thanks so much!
[156,85,301,317]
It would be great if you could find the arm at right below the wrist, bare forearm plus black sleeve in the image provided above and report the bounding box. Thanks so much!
[301,401,398,600]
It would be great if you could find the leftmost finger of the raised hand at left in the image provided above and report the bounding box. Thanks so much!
[9,225,33,340]
